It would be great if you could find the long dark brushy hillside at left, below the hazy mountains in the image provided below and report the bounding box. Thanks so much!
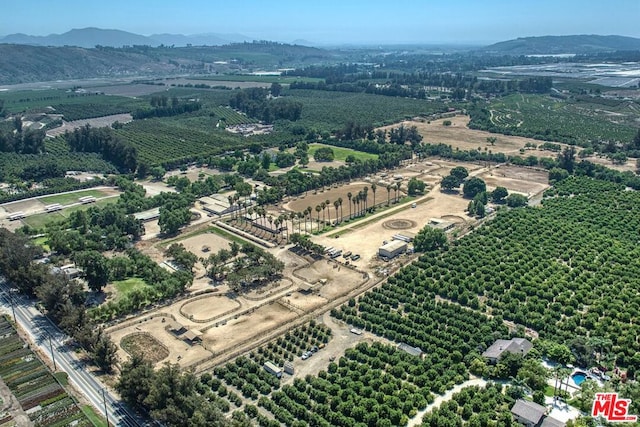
[0,42,333,85]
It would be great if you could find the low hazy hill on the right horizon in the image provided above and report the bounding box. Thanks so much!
[480,35,640,55]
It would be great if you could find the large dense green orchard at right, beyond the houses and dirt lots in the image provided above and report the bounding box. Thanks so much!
[402,178,640,369]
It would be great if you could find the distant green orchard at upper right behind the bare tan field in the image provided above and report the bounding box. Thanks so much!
[486,94,640,145]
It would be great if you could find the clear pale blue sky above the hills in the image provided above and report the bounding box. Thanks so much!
[0,0,640,44]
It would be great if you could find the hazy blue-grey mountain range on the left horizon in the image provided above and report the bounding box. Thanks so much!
[0,28,250,48]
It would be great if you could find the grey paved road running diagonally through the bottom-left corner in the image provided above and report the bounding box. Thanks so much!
[0,278,142,427]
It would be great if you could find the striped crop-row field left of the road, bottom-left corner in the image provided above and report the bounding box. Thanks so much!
[0,317,93,427]
